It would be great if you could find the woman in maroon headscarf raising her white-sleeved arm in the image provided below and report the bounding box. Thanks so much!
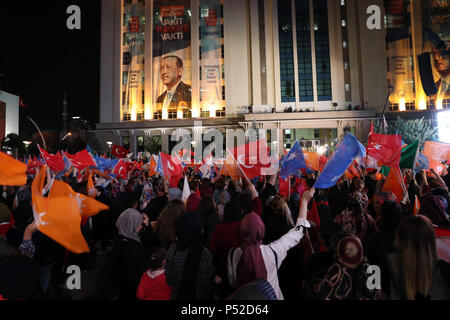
[227,188,315,300]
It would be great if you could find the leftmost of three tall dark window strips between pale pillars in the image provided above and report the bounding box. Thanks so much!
[278,1,295,102]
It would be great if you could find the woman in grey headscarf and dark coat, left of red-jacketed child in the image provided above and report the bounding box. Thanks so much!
[105,208,149,299]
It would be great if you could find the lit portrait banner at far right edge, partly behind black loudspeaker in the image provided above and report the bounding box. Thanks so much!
[419,0,450,103]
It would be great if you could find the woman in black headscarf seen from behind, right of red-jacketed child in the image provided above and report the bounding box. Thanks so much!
[166,212,215,300]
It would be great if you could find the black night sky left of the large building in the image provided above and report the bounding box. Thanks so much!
[0,0,100,135]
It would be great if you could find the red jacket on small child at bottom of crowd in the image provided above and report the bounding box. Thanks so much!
[136,271,172,300]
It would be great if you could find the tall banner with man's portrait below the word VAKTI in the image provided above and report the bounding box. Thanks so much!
[152,0,192,119]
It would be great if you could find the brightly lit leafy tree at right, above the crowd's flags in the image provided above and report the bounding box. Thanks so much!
[388,117,438,145]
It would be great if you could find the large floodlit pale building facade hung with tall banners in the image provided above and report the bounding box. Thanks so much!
[96,0,447,152]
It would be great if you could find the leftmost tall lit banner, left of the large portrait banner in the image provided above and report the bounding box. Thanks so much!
[122,2,145,120]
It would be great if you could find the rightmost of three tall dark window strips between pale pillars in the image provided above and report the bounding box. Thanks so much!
[314,0,332,101]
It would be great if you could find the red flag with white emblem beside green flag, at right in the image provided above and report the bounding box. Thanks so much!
[367,131,402,167]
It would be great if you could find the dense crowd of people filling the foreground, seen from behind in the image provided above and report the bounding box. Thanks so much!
[0,159,450,300]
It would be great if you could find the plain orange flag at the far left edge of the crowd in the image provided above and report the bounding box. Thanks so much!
[0,152,27,186]
